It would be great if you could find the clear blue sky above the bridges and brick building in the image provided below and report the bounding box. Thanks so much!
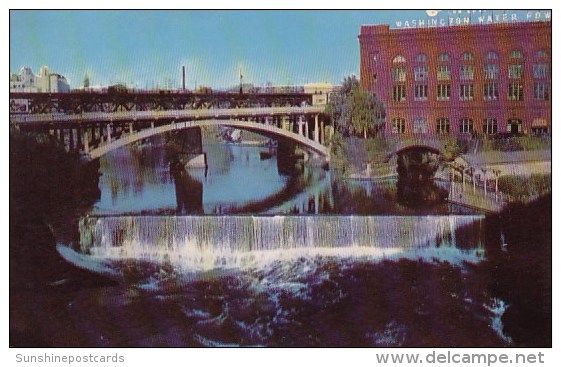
[10,10,548,89]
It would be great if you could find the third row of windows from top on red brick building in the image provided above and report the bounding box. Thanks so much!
[392,82,549,102]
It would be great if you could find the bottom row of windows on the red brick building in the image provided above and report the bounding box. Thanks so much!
[391,117,547,135]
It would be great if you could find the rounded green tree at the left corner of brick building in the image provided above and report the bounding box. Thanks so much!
[326,75,385,138]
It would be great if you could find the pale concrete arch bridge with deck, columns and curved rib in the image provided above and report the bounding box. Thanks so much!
[10,106,330,162]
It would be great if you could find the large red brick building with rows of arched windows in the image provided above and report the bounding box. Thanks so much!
[359,22,551,139]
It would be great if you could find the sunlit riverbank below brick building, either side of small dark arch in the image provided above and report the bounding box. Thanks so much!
[332,135,551,213]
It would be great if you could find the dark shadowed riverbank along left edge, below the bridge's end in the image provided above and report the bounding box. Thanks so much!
[9,131,115,347]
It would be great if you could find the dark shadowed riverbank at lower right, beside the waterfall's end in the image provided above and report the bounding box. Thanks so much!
[483,193,553,348]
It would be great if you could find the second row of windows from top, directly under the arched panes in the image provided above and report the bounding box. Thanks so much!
[392,64,549,82]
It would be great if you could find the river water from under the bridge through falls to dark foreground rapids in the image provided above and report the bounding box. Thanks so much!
[48,141,545,347]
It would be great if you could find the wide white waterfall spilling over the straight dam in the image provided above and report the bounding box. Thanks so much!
[80,215,484,269]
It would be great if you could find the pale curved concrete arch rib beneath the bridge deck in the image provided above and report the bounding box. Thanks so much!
[86,119,330,161]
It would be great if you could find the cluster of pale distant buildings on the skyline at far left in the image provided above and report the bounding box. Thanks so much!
[10,66,70,93]
